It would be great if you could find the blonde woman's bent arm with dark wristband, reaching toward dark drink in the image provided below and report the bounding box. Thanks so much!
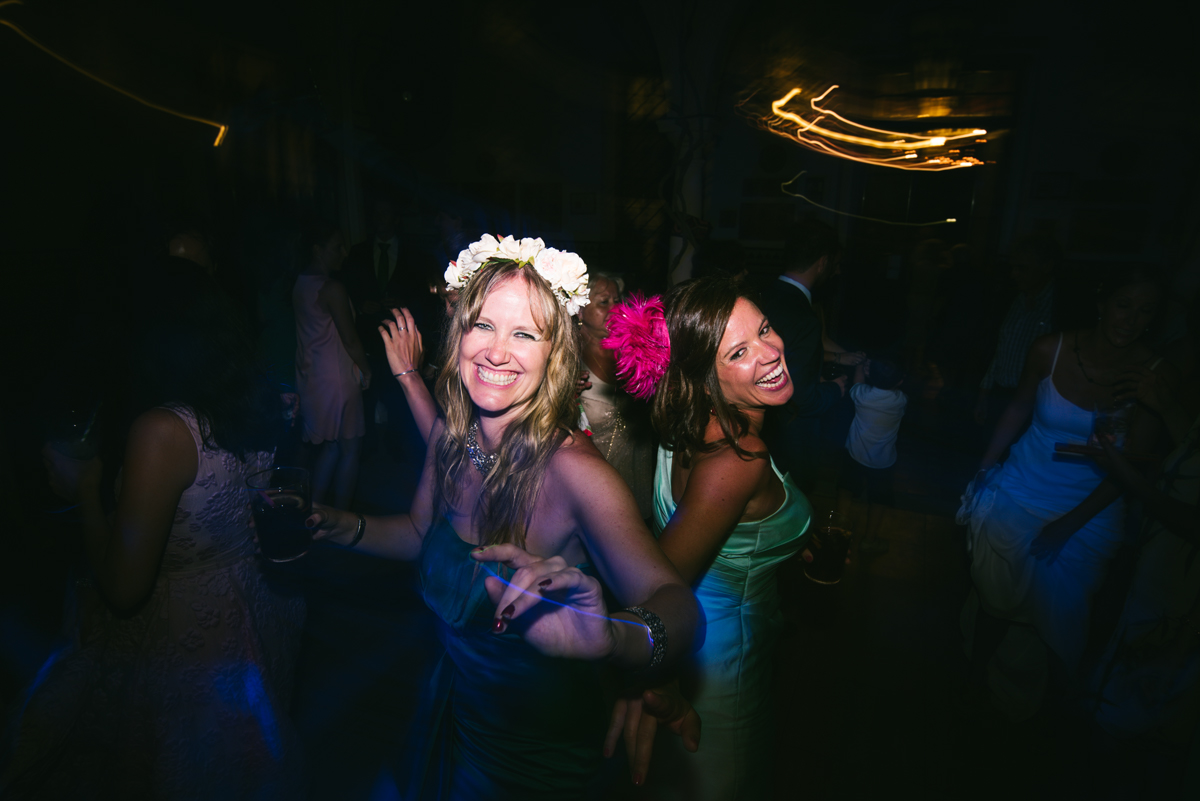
[308,423,440,561]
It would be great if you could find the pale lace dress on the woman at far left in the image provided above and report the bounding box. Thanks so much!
[0,408,305,800]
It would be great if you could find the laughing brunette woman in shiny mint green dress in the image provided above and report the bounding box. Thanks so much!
[609,277,811,800]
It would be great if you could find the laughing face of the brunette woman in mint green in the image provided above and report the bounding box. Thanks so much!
[716,297,793,410]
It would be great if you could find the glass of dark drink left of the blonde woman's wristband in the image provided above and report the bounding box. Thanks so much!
[246,468,312,562]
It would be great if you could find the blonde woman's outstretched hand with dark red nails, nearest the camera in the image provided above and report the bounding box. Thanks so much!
[470,544,632,660]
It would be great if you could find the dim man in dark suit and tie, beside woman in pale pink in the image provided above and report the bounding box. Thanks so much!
[342,198,422,464]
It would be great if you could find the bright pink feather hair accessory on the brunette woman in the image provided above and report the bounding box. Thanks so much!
[600,293,671,401]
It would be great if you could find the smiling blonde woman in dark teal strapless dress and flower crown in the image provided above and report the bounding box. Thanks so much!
[311,236,697,799]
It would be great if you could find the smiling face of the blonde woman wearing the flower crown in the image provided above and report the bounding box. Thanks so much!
[458,276,551,421]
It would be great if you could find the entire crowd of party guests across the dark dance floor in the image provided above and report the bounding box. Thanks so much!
[0,200,1200,800]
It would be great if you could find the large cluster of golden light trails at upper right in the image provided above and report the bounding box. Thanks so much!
[757,84,988,173]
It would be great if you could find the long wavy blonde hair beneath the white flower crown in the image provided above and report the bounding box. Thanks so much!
[433,259,580,548]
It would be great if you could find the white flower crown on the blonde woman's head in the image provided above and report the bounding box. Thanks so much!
[445,234,592,315]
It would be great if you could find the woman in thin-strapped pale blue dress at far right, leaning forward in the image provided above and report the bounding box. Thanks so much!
[962,271,1162,721]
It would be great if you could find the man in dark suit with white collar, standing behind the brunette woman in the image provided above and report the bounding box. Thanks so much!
[761,219,846,492]
